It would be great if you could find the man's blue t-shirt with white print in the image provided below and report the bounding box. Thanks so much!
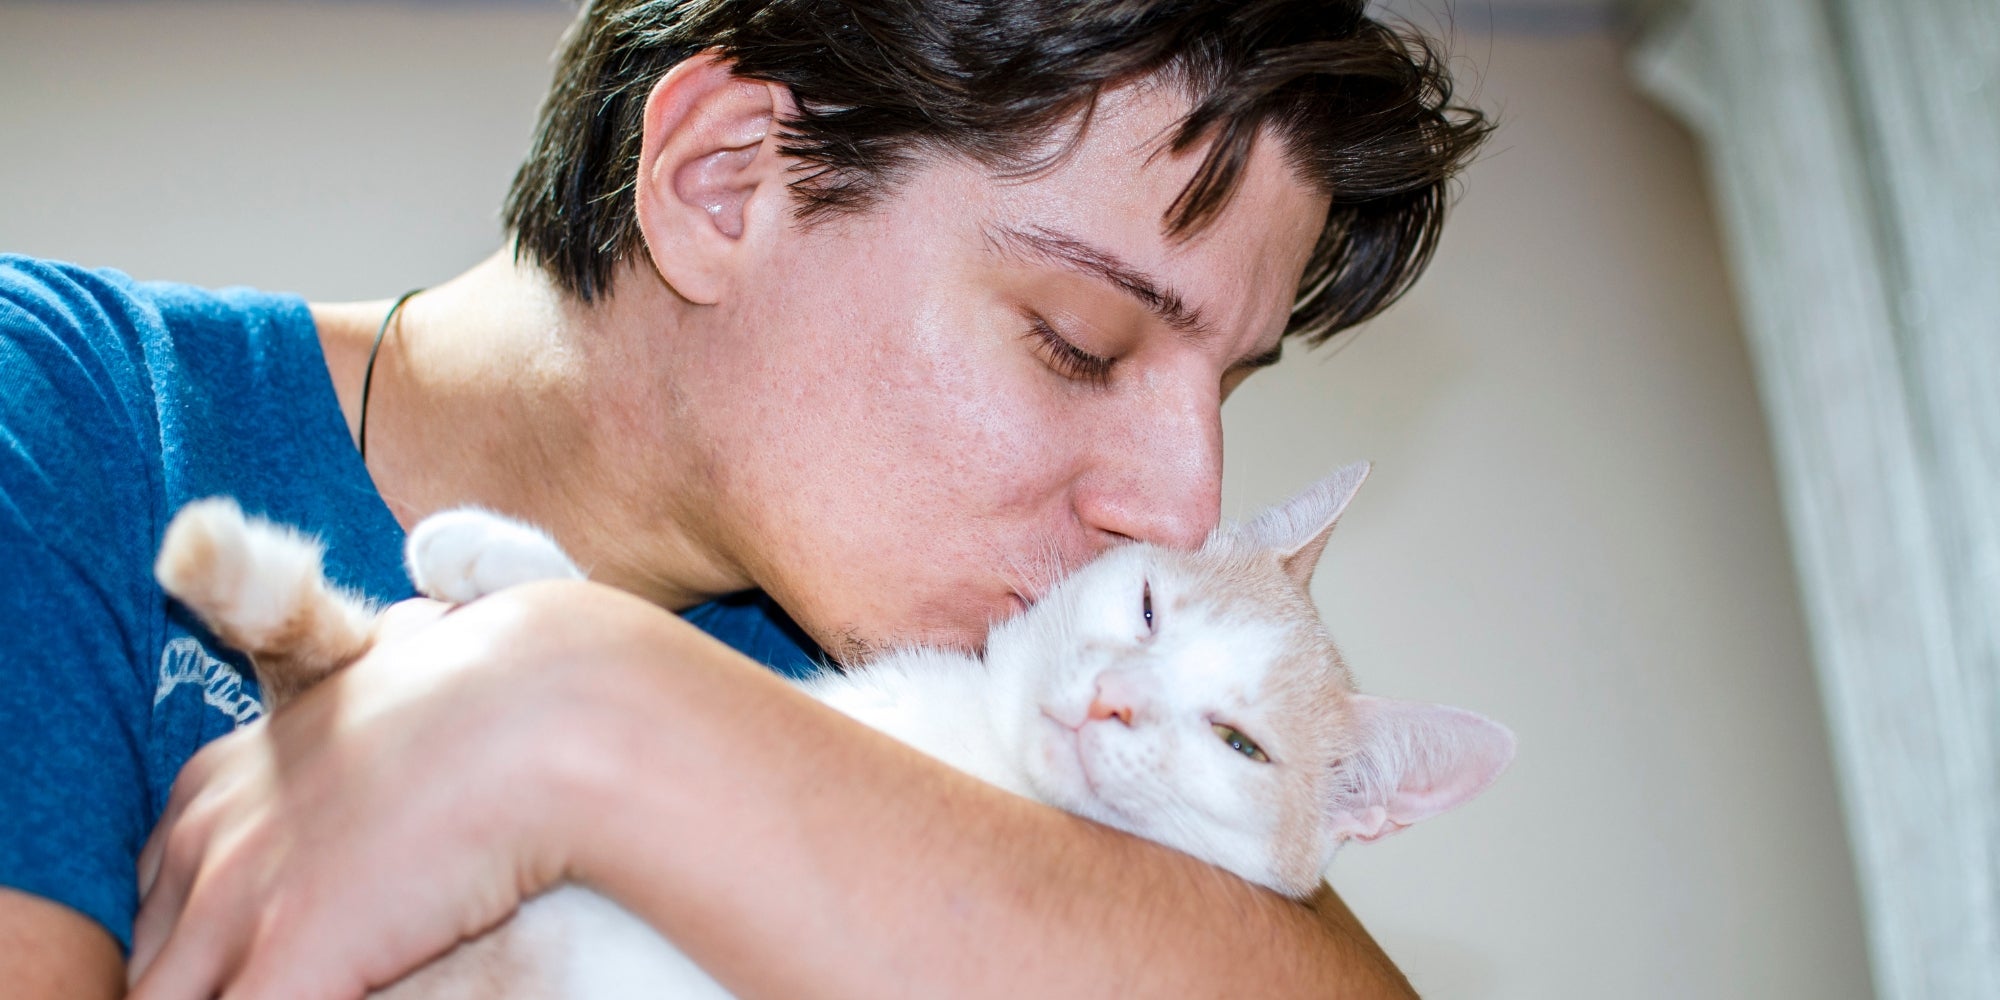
[0,256,818,948]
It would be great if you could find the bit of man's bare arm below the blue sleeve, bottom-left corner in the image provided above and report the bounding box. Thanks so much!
[0,888,124,1000]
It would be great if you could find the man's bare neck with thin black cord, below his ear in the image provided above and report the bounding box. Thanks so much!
[312,250,750,608]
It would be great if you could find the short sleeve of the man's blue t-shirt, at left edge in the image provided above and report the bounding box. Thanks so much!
[0,260,160,948]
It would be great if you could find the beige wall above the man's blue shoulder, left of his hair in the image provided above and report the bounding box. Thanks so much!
[0,0,570,300]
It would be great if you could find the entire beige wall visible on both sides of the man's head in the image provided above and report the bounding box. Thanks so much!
[0,2,1868,1000]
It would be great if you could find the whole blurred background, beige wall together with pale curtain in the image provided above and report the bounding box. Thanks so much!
[0,0,2000,1000]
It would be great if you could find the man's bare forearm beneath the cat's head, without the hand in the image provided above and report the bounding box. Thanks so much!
[540,584,1410,996]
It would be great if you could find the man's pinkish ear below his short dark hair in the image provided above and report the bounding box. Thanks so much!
[632,52,792,306]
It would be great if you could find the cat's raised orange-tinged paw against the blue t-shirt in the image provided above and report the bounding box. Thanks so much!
[152,496,322,652]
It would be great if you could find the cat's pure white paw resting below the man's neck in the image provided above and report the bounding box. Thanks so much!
[404,508,584,604]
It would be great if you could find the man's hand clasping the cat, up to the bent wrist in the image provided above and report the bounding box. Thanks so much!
[130,600,562,1000]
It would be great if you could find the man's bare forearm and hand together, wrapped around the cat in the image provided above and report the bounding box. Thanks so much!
[134,584,1410,1000]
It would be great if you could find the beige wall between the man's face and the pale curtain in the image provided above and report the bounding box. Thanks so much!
[1228,27,1870,1000]
